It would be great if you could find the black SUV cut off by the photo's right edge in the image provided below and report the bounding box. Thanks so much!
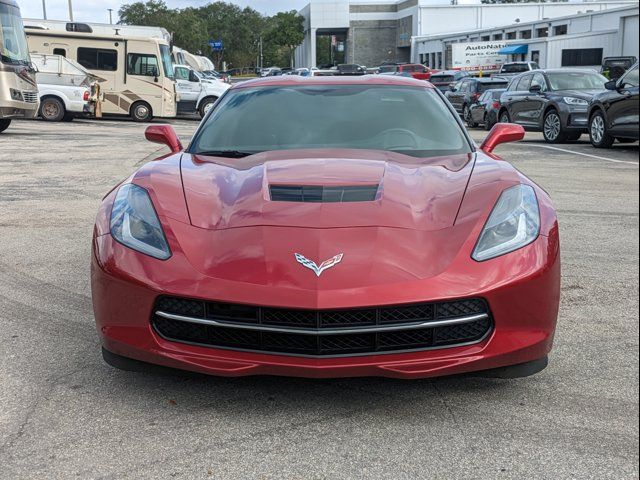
[589,63,640,148]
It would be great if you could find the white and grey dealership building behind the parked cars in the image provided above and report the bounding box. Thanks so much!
[295,0,639,68]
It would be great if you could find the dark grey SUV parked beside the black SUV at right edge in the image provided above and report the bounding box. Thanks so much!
[500,68,607,143]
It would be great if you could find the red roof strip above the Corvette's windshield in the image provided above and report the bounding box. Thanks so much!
[232,75,434,89]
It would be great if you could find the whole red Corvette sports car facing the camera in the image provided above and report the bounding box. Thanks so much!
[92,76,560,378]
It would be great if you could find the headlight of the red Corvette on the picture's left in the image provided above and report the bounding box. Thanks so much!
[111,183,171,260]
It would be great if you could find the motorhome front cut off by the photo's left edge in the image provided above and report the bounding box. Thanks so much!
[0,0,38,132]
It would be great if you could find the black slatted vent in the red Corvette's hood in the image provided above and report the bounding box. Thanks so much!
[269,185,379,203]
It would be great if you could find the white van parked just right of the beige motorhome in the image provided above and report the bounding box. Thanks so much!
[175,65,230,118]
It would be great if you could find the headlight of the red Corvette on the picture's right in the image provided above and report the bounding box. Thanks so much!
[471,185,540,262]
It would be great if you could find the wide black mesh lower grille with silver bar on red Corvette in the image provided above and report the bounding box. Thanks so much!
[151,296,493,356]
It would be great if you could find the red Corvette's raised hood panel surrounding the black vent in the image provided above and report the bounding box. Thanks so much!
[181,150,475,231]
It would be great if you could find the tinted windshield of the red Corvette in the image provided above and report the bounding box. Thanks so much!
[189,85,471,158]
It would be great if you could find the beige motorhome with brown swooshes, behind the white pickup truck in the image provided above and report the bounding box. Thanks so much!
[26,26,177,122]
